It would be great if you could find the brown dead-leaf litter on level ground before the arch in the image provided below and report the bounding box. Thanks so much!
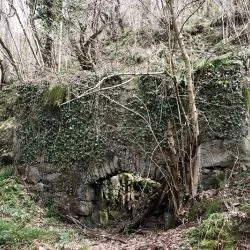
[36,222,192,250]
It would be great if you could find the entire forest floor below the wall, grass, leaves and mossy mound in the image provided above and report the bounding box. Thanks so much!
[0,163,250,250]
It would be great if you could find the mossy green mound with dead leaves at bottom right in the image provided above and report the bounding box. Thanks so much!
[186,164,250,250]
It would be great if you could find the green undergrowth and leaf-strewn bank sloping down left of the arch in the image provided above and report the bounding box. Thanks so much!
[0,166,86,249]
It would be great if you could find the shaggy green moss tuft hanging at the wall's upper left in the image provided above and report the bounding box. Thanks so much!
[44,83,68,107]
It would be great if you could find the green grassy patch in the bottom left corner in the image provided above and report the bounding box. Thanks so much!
[0,166,60,249]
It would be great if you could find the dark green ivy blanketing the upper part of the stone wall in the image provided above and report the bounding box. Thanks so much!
[16,61,246,173]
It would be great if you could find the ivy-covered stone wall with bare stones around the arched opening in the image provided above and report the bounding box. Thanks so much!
[11,60,246,223]
